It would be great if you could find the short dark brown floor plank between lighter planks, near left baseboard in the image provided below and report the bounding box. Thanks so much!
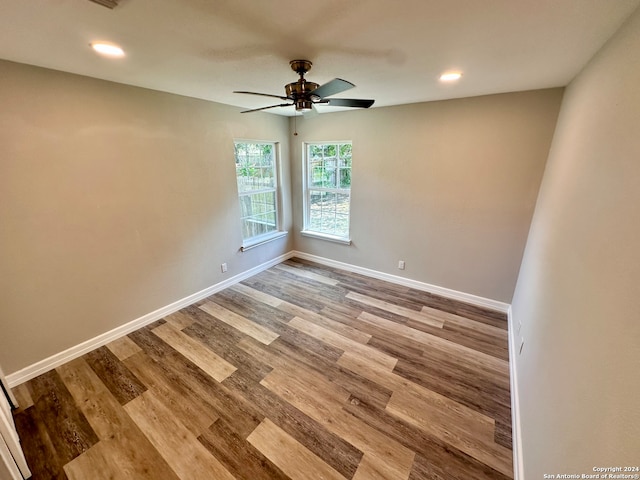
[84,347,147,405]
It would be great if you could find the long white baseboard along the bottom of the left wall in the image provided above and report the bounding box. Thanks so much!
[6,252,293,388]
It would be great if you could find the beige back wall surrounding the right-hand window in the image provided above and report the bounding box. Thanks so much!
[291,89,562,303]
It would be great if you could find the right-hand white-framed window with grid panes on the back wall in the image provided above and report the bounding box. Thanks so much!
[302,142,351,243]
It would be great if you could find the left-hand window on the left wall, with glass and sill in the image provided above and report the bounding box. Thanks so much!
[235,141,286,250]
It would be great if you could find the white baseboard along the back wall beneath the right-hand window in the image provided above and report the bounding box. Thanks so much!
[291,250,509,313]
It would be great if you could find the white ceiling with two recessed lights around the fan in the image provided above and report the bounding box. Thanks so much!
[0,0,640,115]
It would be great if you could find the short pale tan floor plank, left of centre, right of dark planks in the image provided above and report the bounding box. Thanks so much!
[151,323,236,382]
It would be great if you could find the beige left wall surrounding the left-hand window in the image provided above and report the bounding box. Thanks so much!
[0,62,292,373]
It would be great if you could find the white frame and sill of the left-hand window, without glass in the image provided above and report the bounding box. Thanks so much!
[233,138,287,252]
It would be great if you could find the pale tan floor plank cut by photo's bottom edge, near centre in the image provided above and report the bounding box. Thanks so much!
[247,418,345,480]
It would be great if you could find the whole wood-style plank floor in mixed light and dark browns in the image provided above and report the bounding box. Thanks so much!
[14,259,513,480]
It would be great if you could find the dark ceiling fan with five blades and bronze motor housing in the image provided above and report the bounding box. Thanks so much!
[233,60,375,113]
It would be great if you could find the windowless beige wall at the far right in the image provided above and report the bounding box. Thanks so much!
[513,4,640,480]
